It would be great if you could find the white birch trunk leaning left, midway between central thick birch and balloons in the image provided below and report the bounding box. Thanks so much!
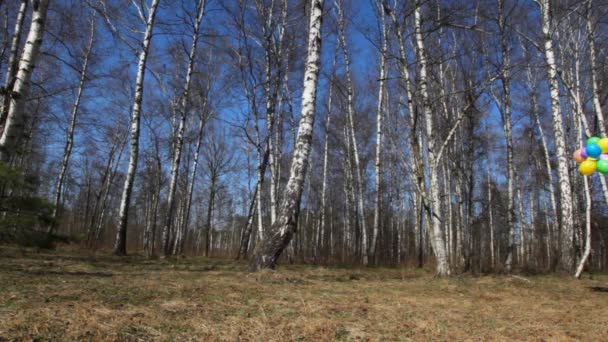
[414,0,450,276]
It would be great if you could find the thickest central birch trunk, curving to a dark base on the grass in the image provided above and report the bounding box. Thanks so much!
[249,0,323,271]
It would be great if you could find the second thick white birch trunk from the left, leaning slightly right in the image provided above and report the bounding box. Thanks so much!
[114,0,160,255]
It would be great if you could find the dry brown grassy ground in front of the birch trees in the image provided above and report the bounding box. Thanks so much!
[0,246,608,341]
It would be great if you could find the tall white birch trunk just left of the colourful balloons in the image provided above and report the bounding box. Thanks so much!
[535,0,574,271]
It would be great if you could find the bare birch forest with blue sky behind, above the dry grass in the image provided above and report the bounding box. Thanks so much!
[0,0,608,275]
